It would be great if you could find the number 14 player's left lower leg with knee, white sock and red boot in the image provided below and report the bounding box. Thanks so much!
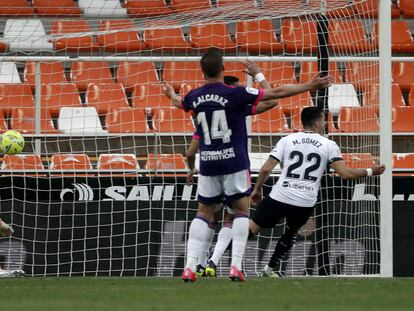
[182,203,216,282]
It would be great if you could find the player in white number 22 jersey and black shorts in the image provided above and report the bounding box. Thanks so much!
[250,107,385,277]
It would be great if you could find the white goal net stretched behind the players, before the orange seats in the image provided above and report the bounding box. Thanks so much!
[0,0,380,276]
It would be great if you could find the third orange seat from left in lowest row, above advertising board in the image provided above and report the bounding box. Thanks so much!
[97,153,139,176]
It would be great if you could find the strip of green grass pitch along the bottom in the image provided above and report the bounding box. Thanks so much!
[0,277,414,311]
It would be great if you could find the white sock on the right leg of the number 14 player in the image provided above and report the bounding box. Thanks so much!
[231,214,249,270]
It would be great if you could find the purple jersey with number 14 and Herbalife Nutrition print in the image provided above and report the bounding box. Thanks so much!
[182,82,264,176]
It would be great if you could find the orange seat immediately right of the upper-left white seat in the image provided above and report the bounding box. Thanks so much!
[50,20,97,51]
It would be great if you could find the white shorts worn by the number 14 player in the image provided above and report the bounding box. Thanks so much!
[197,170,252,205]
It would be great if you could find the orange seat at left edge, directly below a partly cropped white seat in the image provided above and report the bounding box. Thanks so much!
[0,83,34,115]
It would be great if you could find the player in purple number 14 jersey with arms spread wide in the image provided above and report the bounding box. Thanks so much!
[164,48,332,282]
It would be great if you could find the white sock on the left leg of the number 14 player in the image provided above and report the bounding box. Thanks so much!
[185,216,210,271]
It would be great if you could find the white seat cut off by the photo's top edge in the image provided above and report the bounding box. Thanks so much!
[78,0,127,17]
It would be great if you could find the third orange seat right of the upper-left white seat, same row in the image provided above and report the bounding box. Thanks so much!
[144,21,190,52]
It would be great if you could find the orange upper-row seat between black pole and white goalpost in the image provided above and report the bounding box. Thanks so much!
[328,20,373,53]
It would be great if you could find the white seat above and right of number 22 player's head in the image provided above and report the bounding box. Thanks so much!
[328,83,361,116]
